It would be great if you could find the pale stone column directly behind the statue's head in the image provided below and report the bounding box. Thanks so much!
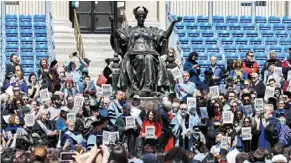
[125,1,160,27]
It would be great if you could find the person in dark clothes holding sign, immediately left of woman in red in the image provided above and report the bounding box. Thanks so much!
[115,102,140,156]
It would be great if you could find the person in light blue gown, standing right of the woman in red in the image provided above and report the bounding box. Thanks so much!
[171,104,200,151]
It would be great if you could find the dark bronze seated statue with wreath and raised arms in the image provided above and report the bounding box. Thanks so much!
[110,7,181,97]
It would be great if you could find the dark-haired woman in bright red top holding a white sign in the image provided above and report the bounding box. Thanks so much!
[141,110,162,146]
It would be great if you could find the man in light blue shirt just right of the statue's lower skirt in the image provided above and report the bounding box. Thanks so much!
[175,71,196,102]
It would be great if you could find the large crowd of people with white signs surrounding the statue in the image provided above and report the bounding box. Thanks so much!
[1,48,291,163]
